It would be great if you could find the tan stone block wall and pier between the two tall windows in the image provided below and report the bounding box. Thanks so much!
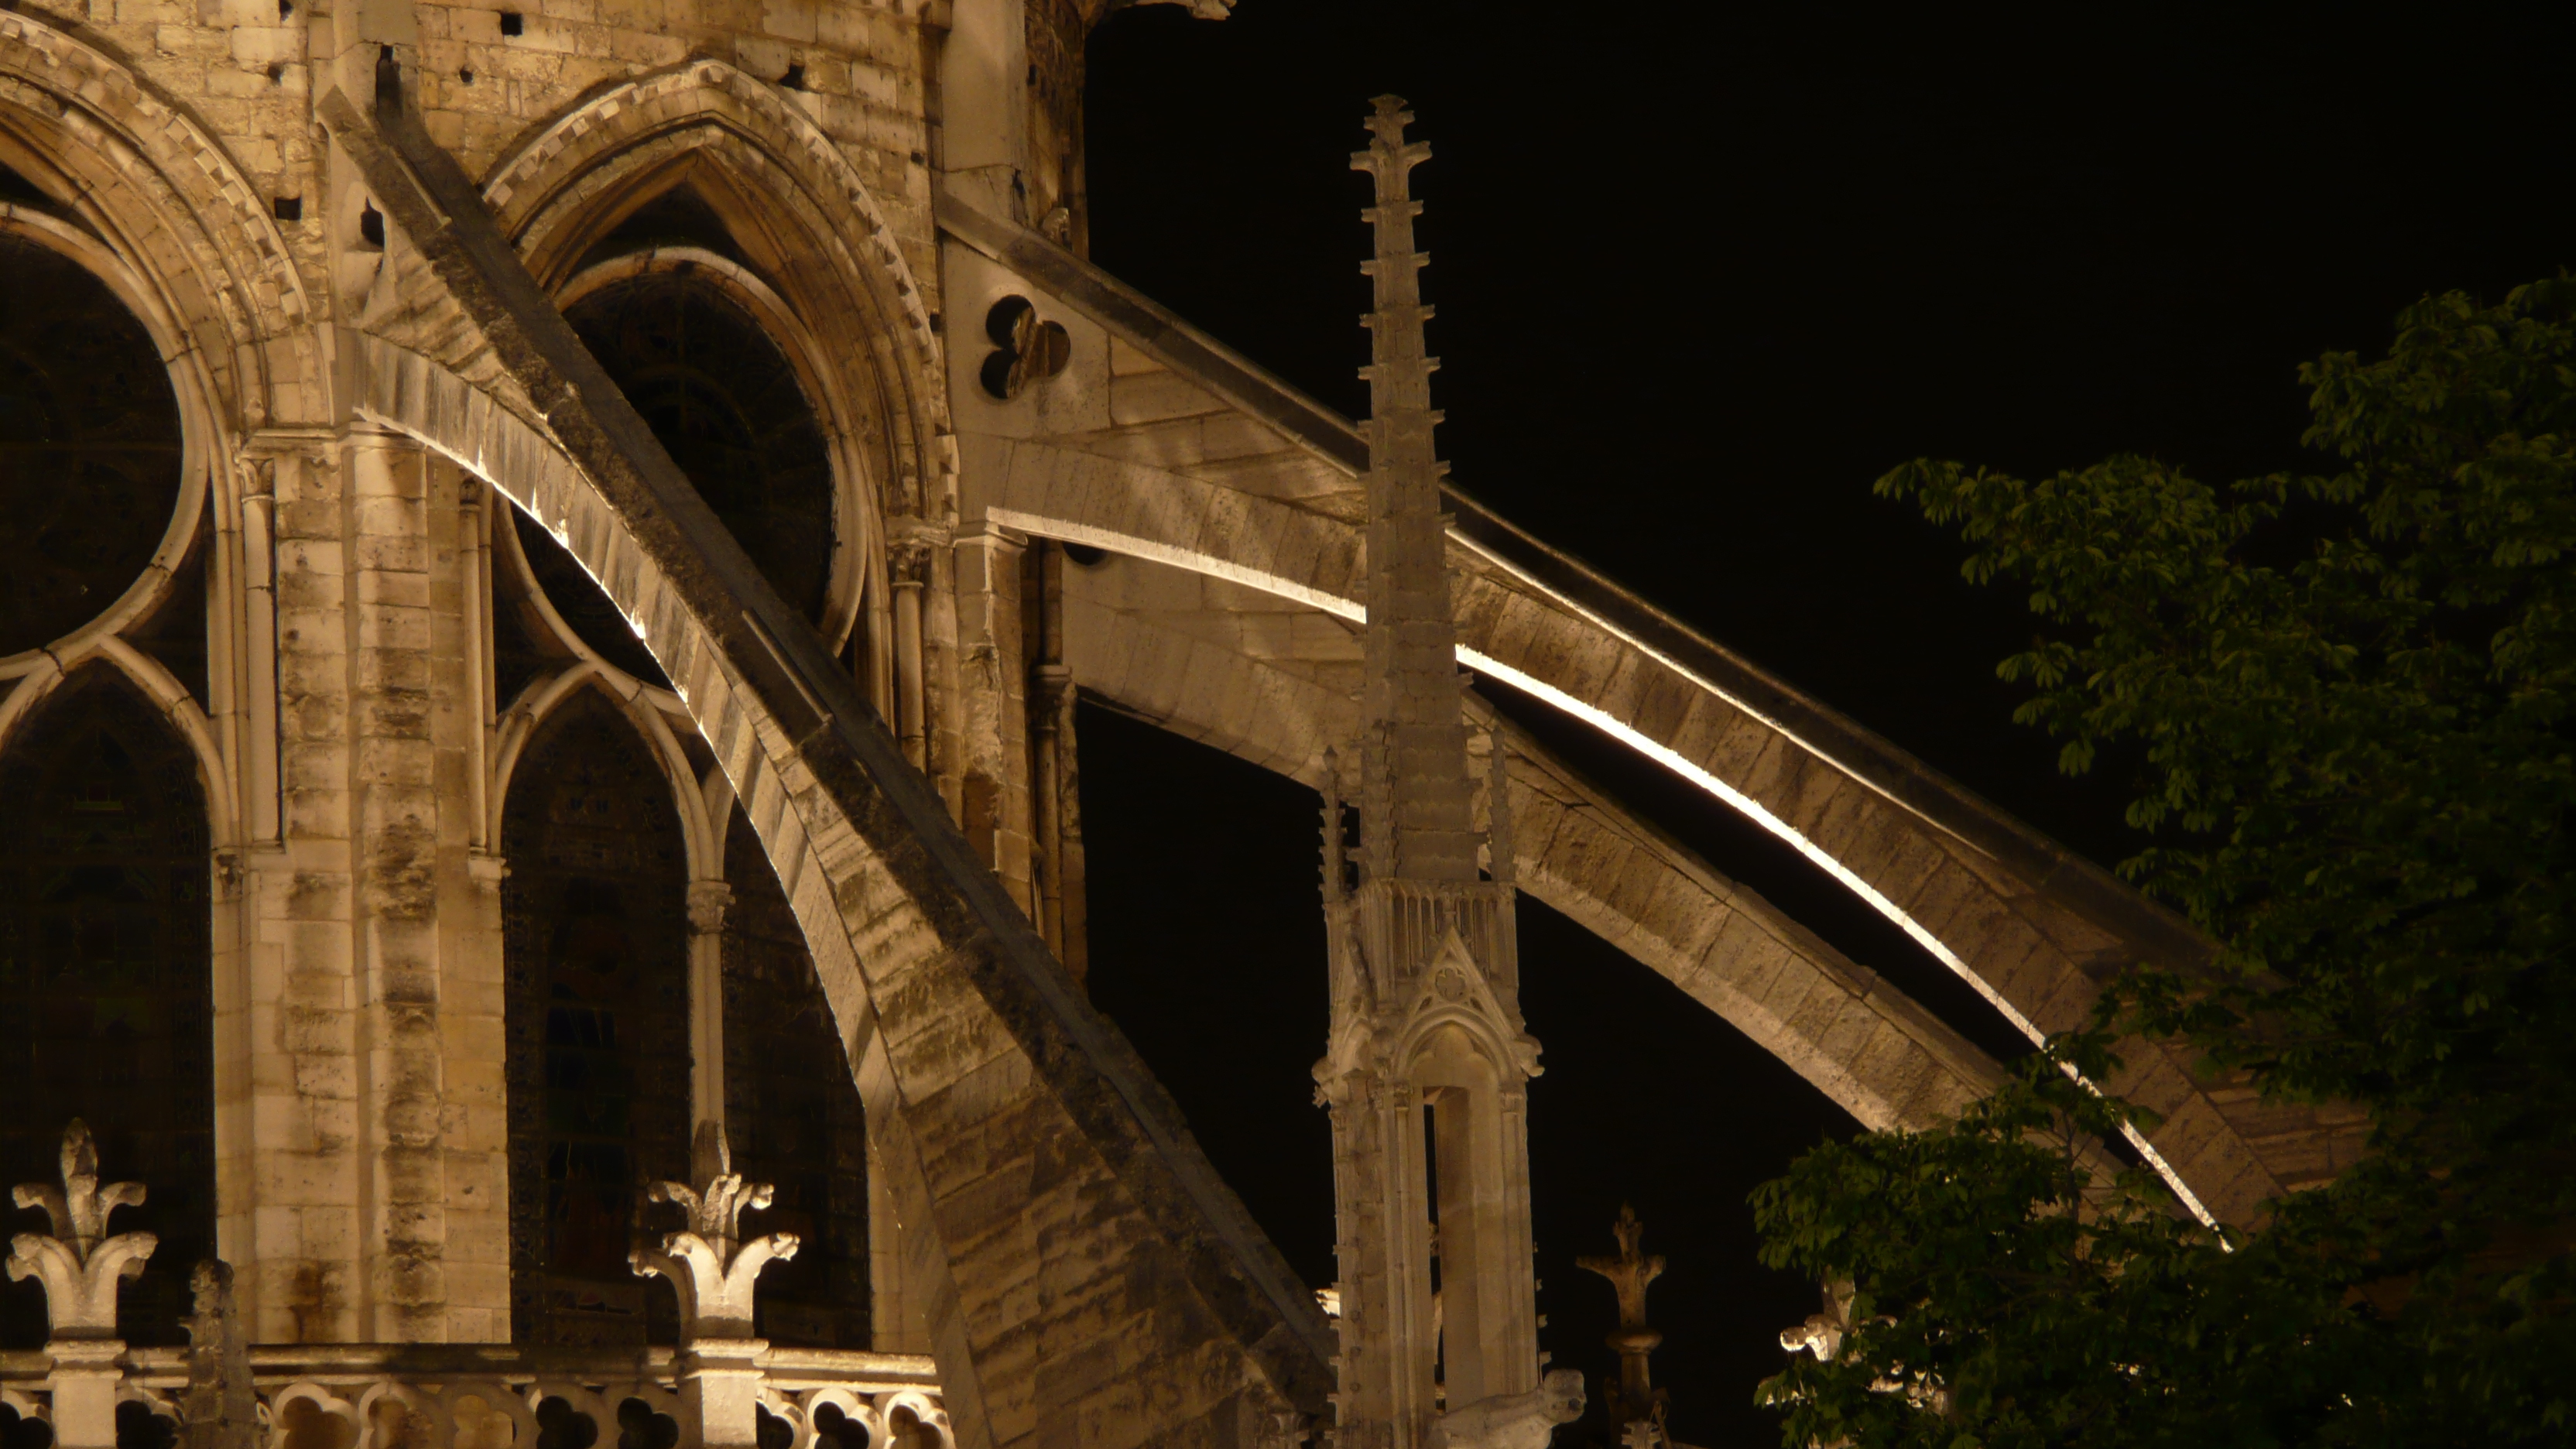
[0,0,968,1343]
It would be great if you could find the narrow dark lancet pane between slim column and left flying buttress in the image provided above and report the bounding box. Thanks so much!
[724,810,868,1348]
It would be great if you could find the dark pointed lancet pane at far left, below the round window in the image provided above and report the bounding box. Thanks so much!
[0,665,214,1348]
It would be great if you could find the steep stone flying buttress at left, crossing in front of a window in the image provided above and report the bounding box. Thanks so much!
[322,79,1332,1449]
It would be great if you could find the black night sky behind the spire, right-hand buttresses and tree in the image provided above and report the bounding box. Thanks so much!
[1061,0,2576,1447]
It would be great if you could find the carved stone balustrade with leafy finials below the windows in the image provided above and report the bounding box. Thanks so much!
[0,1122,956,1449]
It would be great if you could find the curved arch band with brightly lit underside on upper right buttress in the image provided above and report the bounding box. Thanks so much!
[966,438,2280,1222]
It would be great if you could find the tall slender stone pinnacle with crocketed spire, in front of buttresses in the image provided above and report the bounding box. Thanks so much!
[1314,95,1581,1449]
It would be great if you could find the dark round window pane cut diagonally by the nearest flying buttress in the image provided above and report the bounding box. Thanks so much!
[564,271,832,618]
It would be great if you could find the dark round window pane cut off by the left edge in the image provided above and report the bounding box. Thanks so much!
[0,235,180,655]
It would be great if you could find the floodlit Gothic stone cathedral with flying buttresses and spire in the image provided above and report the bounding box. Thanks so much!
[0,0,2331,1449]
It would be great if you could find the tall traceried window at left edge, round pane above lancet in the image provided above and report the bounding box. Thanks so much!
[0,204,217,1348]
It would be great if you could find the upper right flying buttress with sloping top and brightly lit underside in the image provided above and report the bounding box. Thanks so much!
[937,196,2367,1222]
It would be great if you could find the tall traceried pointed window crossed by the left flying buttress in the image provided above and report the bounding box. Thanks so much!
[492,183,871,1348]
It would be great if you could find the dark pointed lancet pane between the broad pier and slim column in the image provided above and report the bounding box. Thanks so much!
[502,691,690,1346]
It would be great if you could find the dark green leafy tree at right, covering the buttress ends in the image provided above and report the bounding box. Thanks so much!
[1754,279,2576,1449]
